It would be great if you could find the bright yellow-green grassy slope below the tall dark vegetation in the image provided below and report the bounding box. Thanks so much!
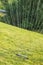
[0,22,43,65]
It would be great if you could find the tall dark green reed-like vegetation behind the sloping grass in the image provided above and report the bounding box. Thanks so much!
[0,0,43,32]
